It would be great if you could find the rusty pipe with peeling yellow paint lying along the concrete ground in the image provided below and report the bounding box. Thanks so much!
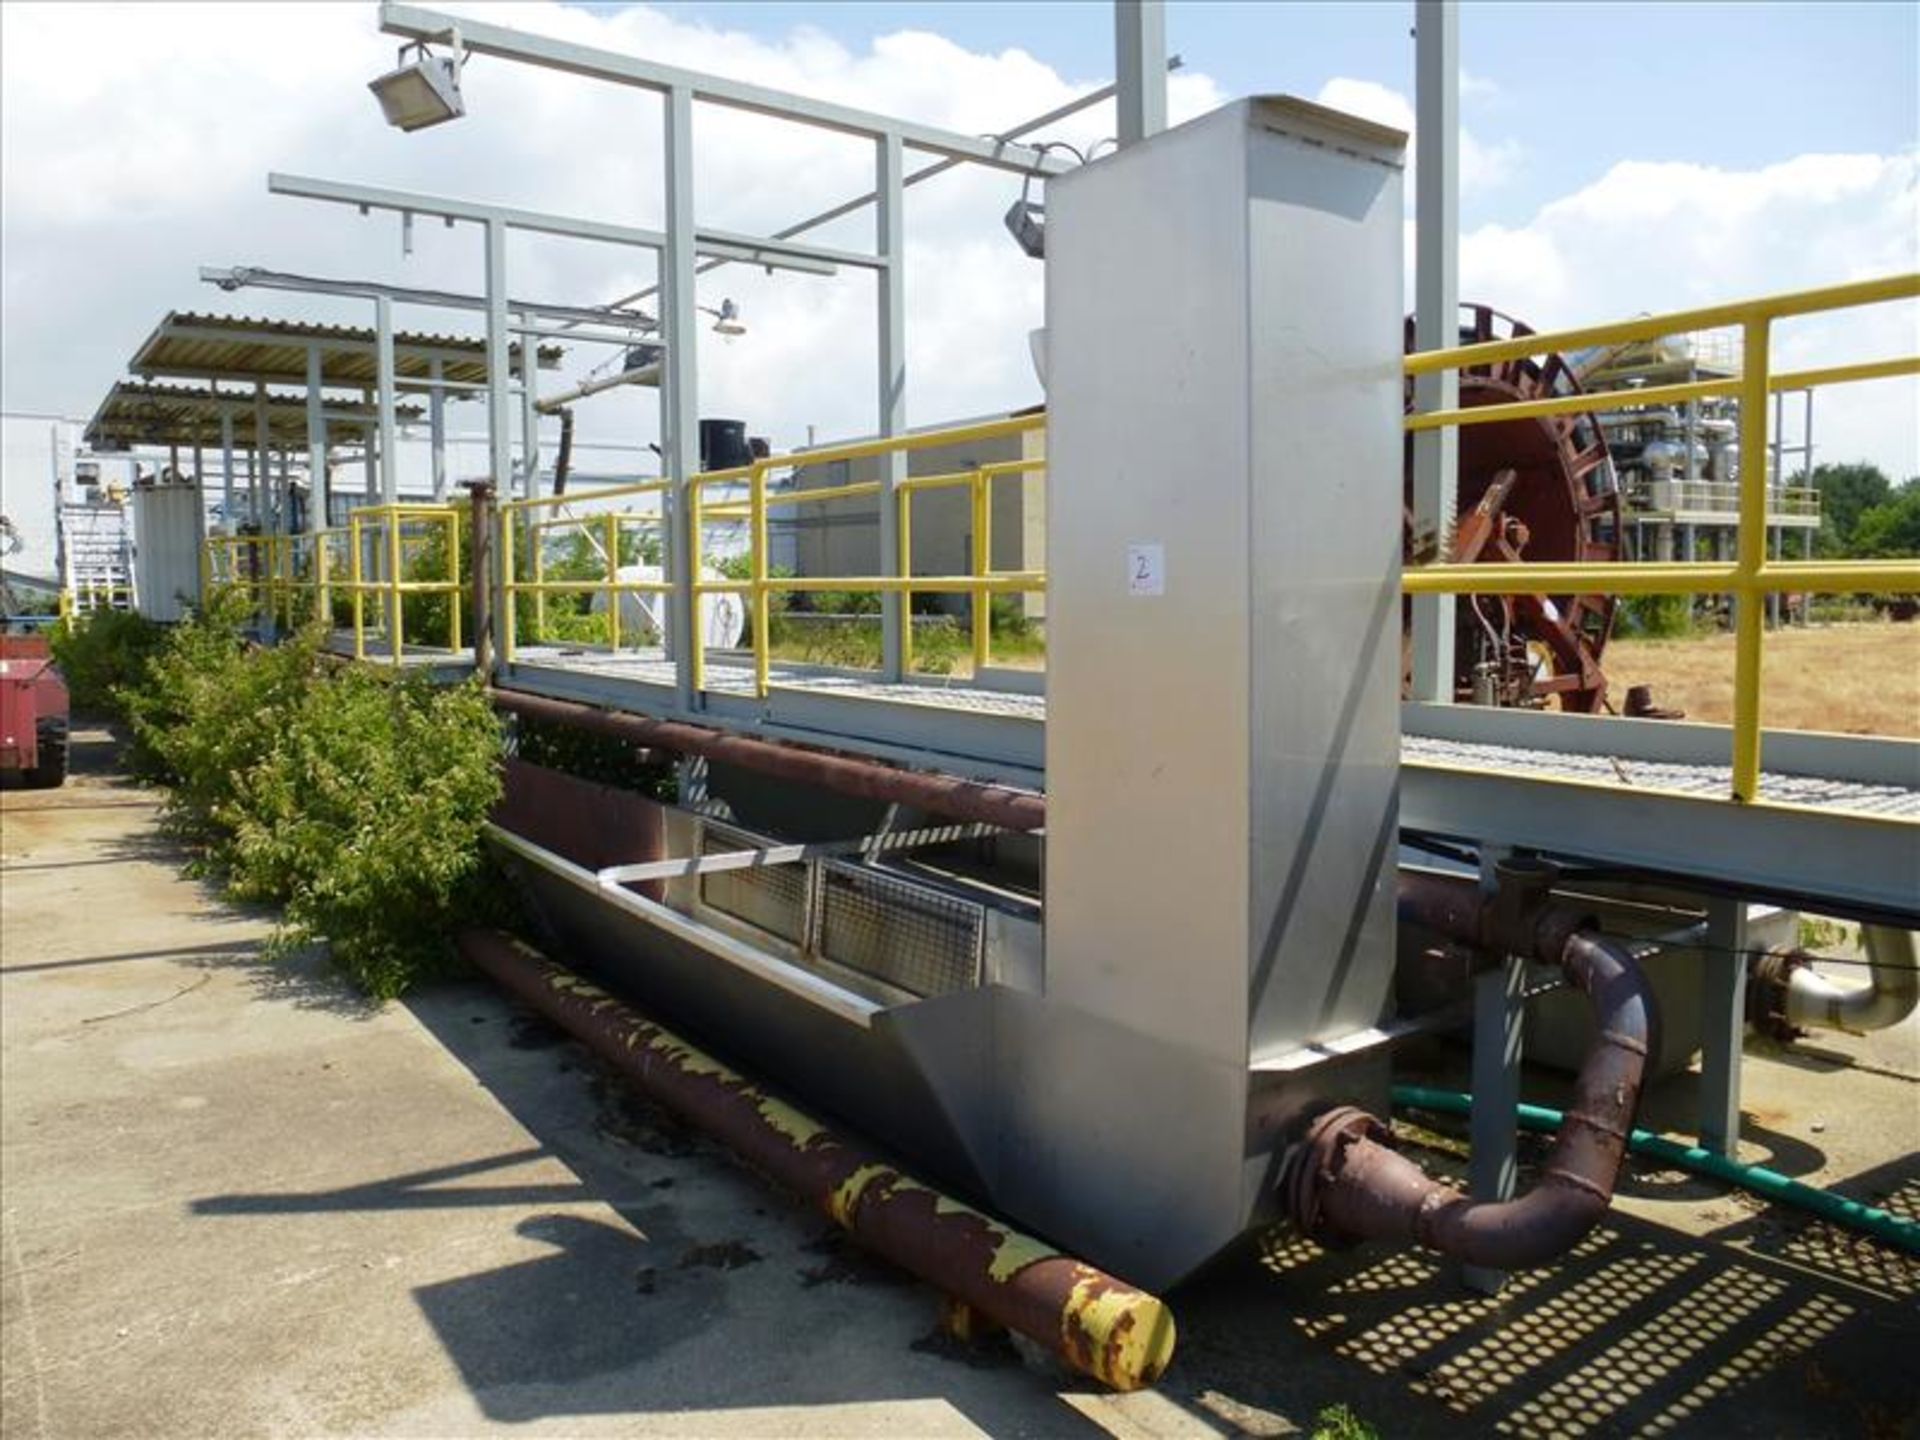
[461,929,1173,1390]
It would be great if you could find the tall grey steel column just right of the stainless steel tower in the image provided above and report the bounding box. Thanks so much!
[1413,0,1459,705]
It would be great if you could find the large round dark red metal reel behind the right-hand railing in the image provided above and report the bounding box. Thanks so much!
[1402,303,1622,710]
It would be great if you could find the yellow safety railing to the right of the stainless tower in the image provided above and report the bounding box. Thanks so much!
[1404,275,1920,801]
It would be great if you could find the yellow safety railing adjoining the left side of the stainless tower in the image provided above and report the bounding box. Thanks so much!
[687,415,1046,697]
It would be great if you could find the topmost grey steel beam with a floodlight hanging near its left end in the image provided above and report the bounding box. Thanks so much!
[380,4,1068,175]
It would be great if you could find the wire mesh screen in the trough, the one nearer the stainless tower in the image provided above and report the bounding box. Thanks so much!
[814,864,985,996]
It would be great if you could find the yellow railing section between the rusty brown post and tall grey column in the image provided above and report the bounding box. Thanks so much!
[499,480,674,664]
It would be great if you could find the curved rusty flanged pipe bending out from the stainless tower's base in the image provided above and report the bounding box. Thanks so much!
[1286,870,1653,1269]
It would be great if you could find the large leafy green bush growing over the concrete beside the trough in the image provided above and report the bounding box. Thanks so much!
[121,597,501,998]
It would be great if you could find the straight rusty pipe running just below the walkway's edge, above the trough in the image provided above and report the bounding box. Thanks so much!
[488,689,1046,831]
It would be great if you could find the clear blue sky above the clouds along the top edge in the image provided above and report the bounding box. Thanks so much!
[637,0,1920,228]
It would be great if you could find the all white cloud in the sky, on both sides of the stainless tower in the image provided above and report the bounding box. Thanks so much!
[0,0,1920,583]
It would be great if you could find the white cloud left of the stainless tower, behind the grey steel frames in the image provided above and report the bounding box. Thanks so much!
[0,2,1223,464]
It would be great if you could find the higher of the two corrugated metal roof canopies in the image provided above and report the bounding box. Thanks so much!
[127,311,564,390]
